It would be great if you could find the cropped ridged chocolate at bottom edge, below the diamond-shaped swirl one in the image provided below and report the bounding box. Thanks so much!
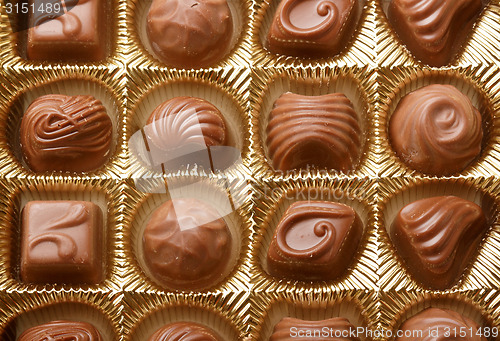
[269,317,359,341]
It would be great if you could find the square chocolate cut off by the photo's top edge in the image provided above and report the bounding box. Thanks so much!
[27,0,107,62]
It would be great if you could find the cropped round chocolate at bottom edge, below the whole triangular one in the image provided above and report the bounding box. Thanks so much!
[396,308,487,341]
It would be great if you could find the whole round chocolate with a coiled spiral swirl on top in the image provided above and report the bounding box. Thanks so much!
[389,84,483,175]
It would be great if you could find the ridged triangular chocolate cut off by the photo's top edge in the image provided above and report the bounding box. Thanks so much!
[388,0,482,66]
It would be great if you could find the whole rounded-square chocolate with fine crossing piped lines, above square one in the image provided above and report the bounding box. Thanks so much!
[21,95,112,172]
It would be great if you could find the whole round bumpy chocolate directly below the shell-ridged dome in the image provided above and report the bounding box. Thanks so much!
[143,198,232,290]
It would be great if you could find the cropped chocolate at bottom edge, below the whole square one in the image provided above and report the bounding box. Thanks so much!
[17,320,102,341]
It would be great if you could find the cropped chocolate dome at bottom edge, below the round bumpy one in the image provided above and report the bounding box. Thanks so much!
[148,322,222,341]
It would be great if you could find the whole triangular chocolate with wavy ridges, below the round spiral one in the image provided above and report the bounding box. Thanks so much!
[391,196,487,289]
